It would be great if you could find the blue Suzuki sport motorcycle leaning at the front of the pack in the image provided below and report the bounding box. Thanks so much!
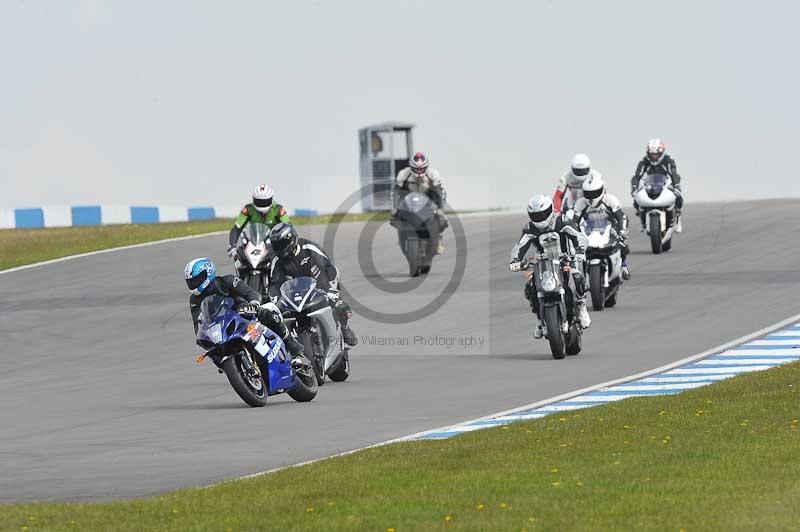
[197,295,317,406]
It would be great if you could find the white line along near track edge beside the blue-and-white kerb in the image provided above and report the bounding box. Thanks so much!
[198,314,800,489]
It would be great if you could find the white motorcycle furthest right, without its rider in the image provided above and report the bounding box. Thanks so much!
[634,174,677,255]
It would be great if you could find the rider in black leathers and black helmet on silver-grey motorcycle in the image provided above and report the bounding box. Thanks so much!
[269,222,358,346]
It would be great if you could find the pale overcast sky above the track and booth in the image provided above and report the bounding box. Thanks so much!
[0,0,800,211]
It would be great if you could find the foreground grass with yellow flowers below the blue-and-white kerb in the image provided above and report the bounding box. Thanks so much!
[0,363,800,532]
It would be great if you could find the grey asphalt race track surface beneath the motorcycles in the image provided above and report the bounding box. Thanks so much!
[0,200,800,502]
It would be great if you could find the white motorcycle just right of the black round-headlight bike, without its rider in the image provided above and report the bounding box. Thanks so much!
[581,211,622,311]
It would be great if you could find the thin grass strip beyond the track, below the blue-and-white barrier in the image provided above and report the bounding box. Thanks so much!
[0,213,388,270]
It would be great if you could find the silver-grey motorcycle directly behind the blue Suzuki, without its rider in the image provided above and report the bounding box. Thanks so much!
[278,277,350,385]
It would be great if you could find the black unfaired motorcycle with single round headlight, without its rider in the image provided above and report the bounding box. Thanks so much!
[523,232,583,359]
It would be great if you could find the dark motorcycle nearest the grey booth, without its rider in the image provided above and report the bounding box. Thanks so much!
[390,192,440,277]
